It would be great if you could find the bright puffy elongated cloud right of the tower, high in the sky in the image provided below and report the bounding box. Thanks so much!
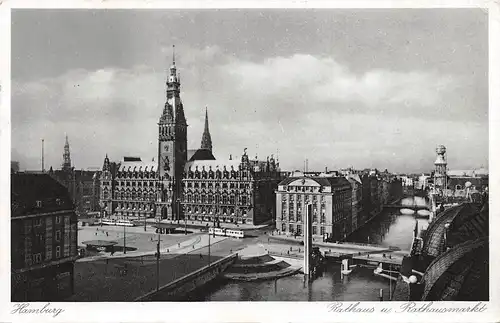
[221,54,457,109]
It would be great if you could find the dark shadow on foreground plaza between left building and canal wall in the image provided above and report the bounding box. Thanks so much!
[65,251,222,302]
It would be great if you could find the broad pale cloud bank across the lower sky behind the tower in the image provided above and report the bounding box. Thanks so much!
[12,46,487,173]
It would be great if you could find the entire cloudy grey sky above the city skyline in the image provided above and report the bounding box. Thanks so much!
[12,9,488,172]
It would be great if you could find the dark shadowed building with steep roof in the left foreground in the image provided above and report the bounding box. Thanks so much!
[11,173,78,302]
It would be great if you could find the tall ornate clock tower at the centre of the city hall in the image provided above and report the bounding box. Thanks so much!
[156,46,187,220]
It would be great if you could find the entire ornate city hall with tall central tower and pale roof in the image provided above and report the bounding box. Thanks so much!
[100,52,283,224]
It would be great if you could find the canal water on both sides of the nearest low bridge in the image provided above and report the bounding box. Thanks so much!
[189,197,427,301]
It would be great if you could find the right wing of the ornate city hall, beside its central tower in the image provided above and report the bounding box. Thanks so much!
[181,151,281,224]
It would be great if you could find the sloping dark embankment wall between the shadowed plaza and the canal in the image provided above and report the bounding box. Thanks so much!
[135,254,238,302]
